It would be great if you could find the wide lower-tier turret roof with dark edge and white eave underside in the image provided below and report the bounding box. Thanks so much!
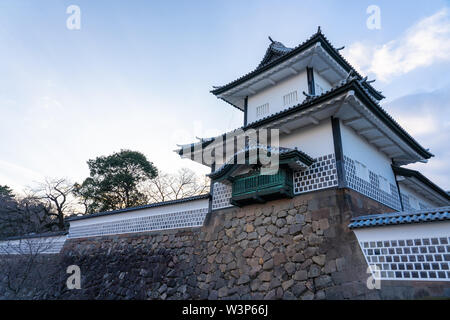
[179,79,433,165]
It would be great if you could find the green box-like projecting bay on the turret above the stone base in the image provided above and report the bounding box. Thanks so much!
[231,167,293,207]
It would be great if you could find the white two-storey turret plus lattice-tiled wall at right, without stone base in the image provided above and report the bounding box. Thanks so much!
[176,27,450,281]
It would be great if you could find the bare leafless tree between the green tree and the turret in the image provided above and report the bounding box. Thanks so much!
[143,168,209,202]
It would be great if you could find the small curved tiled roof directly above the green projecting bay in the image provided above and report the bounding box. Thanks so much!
[208,146,315,181]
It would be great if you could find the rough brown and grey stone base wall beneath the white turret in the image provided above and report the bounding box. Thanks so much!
[0,189,448,299]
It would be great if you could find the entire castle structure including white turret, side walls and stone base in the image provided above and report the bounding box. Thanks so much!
[4,28,450,300]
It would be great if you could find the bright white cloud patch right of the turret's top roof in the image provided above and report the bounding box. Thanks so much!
[346,8,450,82]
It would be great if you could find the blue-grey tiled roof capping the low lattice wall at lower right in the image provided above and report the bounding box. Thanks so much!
[348,207,450,229]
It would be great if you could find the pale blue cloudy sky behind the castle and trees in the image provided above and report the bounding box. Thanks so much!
[0,0,450,192]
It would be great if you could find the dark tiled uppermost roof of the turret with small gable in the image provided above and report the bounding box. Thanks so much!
[211,27,384,104]
